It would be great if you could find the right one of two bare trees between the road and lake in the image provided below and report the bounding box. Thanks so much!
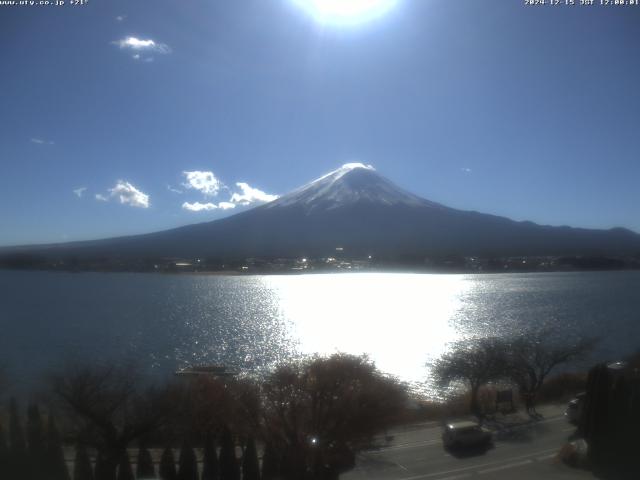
[505,329,596,413]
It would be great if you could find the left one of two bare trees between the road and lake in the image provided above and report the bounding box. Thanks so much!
[431,337,506,415]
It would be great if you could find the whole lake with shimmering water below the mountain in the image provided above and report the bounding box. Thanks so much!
[0,271,640,398]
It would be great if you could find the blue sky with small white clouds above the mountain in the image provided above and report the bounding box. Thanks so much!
[0,0,640,245]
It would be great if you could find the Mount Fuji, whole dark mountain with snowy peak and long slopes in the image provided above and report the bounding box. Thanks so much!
[5,163,640,259]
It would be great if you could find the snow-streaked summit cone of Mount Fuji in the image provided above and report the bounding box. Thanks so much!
[265,163,444,213]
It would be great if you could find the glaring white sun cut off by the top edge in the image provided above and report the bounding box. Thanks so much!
[293,0,398,24]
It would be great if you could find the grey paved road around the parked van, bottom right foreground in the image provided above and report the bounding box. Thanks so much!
[340,406,594,480]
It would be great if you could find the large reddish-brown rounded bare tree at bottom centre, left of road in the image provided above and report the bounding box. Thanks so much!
[263,354,406,479]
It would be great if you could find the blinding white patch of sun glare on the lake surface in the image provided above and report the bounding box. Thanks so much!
[263,274,469,388]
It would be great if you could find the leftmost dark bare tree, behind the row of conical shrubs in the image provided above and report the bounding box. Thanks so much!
[52,367,170,480]
